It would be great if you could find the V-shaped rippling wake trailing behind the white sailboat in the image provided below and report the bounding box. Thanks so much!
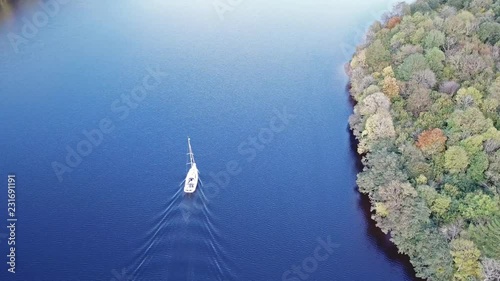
[124,180,236,281]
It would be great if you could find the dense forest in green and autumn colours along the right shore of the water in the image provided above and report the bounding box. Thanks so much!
[346,0,500,280]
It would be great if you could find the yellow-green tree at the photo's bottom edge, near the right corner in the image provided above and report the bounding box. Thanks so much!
[451,239,482,281]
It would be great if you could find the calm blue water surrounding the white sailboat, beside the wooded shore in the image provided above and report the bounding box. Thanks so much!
[0,0,414,281]
